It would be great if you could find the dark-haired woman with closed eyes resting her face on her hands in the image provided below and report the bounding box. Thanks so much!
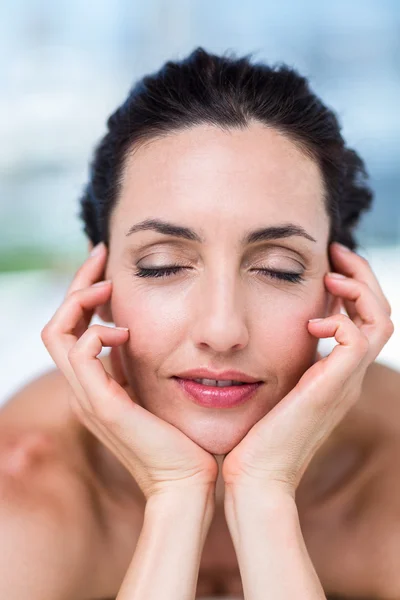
[0,48,400,600]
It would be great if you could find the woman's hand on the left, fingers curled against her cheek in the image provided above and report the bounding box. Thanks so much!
[41,244,218,500]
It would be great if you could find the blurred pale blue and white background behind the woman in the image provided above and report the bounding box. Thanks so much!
[0,0,400,403]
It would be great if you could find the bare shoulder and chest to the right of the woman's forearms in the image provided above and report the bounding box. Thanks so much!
[296,362,400,598]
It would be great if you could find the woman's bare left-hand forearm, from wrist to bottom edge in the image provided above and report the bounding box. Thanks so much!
[117,488,214,600]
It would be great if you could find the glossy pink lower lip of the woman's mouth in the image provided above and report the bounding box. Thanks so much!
[173,376,262,408]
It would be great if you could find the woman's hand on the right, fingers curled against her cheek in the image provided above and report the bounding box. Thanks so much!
[222,244,394,497]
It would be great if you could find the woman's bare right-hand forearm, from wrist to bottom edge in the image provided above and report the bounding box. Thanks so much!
[225,488,325,600]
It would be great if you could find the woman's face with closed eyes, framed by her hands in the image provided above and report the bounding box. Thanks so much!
[102,123,333,454]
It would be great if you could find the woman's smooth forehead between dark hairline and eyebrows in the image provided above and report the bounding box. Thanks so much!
[111,123,327,235]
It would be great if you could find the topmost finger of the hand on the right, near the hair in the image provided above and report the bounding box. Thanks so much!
[330,243,392,317]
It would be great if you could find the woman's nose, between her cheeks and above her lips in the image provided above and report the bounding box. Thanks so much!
[192,274,249,353]
